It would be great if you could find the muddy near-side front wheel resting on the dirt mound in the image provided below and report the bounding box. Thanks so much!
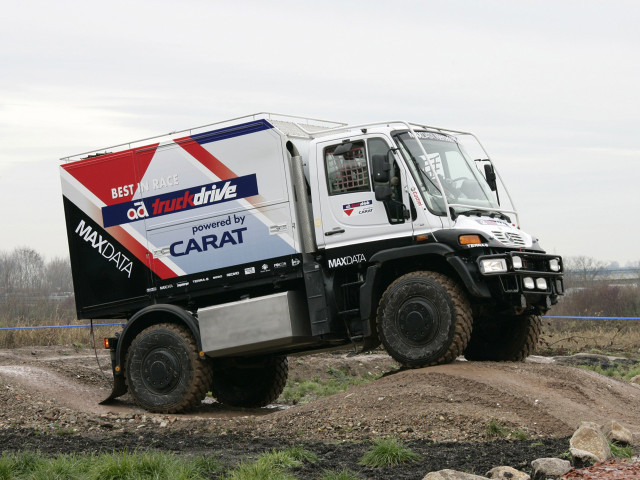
[377,272,472,368]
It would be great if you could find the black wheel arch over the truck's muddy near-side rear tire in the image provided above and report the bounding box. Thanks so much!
[114,304,202,375]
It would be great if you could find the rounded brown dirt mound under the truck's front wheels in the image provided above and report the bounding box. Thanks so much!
[262,361,640,441]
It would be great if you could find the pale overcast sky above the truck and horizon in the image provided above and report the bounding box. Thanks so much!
[0,0,640,265]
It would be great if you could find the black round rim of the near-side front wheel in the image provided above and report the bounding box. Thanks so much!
[396,297,440,346]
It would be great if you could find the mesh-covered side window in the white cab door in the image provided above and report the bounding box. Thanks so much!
[324,141,371,195]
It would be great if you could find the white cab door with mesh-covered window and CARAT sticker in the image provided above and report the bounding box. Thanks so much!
[316,136,413,249]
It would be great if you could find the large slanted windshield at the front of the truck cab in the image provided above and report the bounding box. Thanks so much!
[395,131,499,215]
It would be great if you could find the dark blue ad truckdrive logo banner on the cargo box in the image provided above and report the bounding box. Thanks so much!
[102,174,258,228]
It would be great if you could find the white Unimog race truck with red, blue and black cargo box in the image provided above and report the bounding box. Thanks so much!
[60,114,564,412]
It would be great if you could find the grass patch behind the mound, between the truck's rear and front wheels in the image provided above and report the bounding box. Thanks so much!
[278,367,381,405]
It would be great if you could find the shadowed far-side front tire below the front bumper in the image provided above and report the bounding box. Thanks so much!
[464,315,542,362]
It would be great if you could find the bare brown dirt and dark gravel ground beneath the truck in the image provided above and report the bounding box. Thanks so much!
[0,347,640,479]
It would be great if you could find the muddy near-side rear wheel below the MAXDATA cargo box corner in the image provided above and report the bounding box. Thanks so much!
[125,323,211,413]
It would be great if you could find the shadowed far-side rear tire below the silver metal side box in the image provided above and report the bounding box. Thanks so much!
[211,356,289,408]
